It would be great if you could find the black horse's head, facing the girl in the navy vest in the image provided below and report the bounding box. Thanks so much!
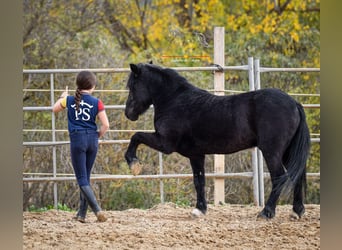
[125,64,152,121]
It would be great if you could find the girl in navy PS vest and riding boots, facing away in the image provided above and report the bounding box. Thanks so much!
[52,71,109,223]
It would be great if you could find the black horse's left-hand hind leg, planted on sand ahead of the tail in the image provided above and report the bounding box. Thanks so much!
[258,154,286,219]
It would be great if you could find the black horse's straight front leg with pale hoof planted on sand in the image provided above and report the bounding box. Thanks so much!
[190,155,207,217]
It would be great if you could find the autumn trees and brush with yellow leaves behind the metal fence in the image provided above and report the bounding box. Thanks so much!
[23,0,320,210]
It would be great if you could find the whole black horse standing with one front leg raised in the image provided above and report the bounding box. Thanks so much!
[125,63,310,218]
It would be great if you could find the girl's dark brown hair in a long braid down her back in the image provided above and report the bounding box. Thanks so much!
[75,71,97,110]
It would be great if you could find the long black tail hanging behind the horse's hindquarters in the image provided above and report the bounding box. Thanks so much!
[283,103,310,197]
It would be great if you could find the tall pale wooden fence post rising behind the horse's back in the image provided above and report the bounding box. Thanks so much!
[214,27,225,205]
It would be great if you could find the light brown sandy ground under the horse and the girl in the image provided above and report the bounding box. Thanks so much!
[23,203,320,250]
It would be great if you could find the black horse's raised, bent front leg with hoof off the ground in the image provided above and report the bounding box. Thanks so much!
[125,132,163,175]
